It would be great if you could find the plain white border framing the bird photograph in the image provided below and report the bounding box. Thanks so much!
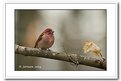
[5,3,118,79]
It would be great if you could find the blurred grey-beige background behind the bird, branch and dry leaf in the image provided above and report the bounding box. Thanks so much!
[15,9,107,71]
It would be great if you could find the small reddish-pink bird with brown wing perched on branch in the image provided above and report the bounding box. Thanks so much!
[34,28,54,50]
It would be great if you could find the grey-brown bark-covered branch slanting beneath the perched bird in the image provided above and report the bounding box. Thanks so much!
[15,45,106,70]
